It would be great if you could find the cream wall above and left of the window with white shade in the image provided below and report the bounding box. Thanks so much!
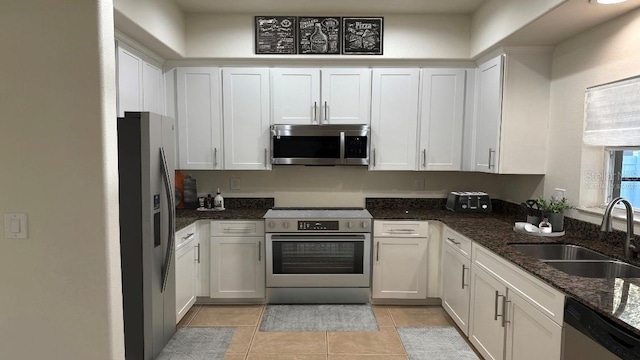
[544,9,640,222]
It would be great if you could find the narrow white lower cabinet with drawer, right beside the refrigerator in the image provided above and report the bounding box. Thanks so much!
[175,223,200,323]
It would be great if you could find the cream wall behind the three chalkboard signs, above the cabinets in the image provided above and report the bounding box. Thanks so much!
[186,14,470,61]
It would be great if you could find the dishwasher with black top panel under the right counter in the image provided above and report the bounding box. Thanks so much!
[563,298,640,360]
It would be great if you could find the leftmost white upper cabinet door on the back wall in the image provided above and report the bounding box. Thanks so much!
[176,67,223,170]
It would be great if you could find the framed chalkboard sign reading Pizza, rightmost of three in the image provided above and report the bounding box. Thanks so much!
[342,17,383,55]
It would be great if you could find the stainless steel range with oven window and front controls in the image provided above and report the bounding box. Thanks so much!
[264,208,371,304]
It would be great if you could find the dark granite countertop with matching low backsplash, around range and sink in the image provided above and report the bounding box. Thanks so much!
[176,199,640,335]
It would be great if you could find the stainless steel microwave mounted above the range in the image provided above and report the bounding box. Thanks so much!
[271,125,370,165]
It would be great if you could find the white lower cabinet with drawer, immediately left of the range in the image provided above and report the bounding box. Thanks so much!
[210,220,265,299]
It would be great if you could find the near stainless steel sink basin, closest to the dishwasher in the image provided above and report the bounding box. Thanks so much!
[543,260,640,279]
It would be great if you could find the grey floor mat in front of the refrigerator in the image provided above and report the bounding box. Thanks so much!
[156,327,235,360]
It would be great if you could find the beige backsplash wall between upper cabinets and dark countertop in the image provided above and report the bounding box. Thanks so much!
[184,166,542,207]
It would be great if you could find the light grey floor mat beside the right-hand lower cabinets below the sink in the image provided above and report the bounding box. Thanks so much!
[398,327,478,360]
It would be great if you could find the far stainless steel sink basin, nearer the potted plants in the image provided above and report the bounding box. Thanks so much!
[509,244,611,260]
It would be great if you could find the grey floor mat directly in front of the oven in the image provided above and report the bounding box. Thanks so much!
[260,305,378,331]
